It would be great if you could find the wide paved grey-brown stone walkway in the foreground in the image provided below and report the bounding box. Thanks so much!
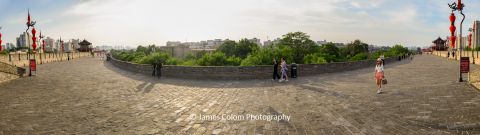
[0,55,480,135]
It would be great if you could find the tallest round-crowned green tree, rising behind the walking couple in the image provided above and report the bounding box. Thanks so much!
[279,32,316,63]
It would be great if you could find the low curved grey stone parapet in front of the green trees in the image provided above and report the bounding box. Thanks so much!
[110,58,397,79]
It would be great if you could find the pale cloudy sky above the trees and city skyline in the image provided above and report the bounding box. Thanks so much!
[0,0,480,47]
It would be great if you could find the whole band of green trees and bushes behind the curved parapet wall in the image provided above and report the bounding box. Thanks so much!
[112,32,410,66]
